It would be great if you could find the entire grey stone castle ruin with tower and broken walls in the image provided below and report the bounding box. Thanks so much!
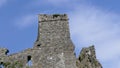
[0,14,102,68]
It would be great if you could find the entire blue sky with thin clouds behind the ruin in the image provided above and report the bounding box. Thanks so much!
[0,0,120,68]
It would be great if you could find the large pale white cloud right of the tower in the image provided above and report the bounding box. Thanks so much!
[70,6,120,68]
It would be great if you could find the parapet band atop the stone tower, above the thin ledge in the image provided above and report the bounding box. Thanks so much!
[39,14,68,22]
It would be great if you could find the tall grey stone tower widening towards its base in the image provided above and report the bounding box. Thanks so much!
[33,14,76,68]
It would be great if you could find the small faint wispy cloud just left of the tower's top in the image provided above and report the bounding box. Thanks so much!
[15,15,37,28]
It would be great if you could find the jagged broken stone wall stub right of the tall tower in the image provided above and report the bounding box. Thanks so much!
[76,46,102,68]
